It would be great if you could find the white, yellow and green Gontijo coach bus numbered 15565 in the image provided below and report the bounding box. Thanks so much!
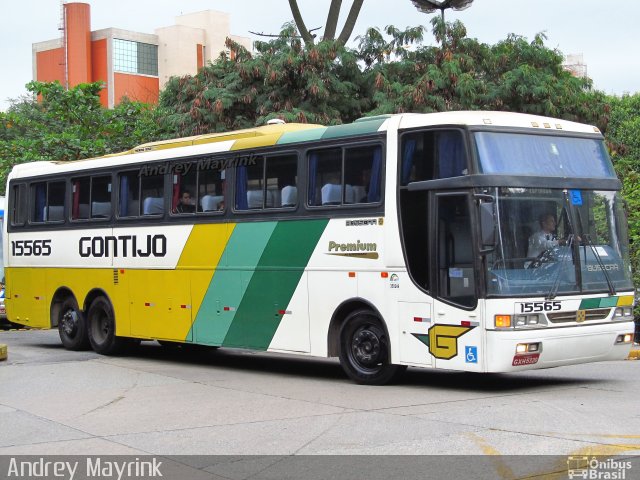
[4,112,634,384]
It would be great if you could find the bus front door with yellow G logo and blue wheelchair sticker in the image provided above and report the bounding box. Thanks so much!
[429,192,483,371]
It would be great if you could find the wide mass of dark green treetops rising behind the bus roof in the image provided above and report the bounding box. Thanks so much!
[161,17,609,135]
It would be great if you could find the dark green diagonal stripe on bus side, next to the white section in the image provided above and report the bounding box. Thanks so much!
[223,220,328,350]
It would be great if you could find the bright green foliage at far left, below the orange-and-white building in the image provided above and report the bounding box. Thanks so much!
[0,82,168,191]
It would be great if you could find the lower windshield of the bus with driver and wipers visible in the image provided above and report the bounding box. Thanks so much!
[486,188,633,298]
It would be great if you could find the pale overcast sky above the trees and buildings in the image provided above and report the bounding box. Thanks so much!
[0,0,640,110]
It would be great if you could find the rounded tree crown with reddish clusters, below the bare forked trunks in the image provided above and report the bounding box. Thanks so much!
[160,29,370,135]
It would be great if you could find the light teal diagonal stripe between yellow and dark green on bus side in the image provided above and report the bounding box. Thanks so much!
[191,222,277,345]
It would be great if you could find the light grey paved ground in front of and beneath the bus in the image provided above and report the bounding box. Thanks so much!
[0,331,640,464]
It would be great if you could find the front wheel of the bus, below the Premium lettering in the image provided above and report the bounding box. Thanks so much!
[340,310,406,385]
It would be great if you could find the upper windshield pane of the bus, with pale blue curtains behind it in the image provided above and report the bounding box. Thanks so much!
[474,132,616,178]
